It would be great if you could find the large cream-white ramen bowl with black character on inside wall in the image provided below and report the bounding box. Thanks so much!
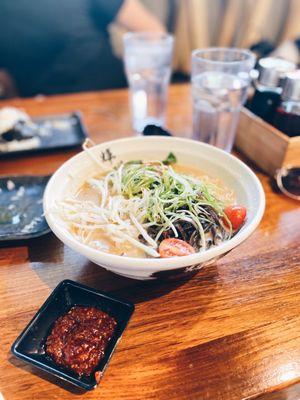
[44,136,265,279]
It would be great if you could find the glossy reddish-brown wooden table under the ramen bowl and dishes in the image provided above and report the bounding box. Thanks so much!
[0,85,300,400]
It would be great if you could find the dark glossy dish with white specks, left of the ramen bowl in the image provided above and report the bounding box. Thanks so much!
[0,175,50,242]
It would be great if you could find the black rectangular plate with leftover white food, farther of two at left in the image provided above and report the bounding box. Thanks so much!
[0,112,87,158]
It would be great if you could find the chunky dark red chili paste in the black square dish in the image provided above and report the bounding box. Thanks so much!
[45,306,117,376]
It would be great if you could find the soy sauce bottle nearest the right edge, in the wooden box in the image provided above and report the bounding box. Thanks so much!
[273,70,300,137]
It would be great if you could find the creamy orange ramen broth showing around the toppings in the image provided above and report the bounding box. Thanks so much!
[71,164,236,258]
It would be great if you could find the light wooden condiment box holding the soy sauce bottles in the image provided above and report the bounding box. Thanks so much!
[235,108,300,176]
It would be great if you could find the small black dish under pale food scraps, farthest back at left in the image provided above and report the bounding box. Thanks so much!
[0,112,87,158]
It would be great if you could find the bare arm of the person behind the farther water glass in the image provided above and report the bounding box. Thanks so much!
[115,0,165,32]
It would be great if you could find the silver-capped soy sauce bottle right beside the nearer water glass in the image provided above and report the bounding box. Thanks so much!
[249,57,296,122]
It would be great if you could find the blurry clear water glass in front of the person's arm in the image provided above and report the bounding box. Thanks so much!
[124,32,173,132]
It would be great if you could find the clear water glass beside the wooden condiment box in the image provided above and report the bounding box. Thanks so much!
[191,48,255,152]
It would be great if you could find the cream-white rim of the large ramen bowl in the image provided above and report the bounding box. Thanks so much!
[43,136,265,271]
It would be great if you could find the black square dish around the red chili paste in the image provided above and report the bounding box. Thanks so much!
[11,280,134,390]
